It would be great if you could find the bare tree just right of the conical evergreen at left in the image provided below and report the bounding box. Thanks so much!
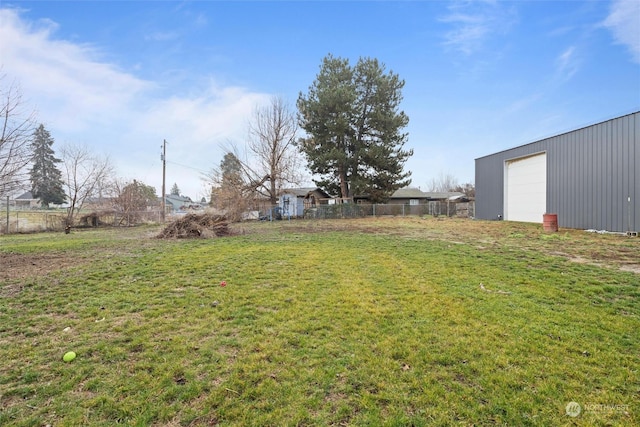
[61,144,113,225]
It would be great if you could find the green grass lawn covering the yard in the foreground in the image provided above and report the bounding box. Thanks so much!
[0,219,640,427]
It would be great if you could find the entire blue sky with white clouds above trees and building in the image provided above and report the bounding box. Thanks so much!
[0,0,640,199]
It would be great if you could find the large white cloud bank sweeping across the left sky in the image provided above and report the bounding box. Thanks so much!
[0,8,269,197]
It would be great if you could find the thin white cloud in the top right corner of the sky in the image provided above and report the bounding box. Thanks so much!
[603,0,640,63]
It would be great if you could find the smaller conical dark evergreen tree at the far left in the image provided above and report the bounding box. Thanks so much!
[29,124,66,207]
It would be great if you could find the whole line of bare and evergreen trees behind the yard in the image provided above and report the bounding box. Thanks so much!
[0,55,473,227]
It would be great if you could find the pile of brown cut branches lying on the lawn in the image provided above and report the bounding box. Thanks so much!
[158,213,232,239]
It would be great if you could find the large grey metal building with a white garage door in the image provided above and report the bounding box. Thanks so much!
[476,111,640,232]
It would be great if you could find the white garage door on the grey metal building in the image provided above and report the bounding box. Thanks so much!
[504,153,547,222]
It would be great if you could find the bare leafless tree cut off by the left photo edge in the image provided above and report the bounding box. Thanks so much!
[0,76,35,196]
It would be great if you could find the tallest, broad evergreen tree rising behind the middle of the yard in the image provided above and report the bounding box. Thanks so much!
[297,55,413,202]
